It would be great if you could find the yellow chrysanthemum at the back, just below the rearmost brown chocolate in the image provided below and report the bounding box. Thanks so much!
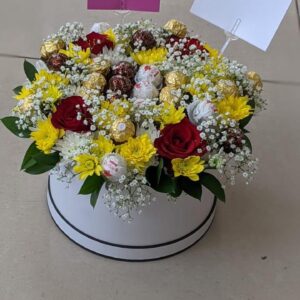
[131,47,168,65]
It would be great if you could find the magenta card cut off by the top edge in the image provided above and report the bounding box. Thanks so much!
[88,0,160,12]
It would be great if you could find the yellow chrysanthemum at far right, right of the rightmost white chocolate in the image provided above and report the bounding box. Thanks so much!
[215,96,252,121]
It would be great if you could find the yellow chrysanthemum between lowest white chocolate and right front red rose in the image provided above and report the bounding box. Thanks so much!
[118,134,156,172]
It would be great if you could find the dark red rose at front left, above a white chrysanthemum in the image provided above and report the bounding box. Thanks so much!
[51,96,92,132]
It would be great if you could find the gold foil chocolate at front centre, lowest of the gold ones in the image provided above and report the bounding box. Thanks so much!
[110,118,135,143]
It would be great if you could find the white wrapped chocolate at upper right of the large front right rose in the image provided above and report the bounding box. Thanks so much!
[187,100,214,125]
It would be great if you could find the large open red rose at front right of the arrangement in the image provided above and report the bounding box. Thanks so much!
[154,118,206,159]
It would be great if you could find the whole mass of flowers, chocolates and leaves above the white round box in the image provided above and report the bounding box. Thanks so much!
[2,20,266,219]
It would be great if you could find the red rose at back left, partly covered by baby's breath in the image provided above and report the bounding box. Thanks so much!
[75,32,114,55]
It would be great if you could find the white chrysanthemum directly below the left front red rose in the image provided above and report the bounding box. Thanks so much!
[55,131,92,161]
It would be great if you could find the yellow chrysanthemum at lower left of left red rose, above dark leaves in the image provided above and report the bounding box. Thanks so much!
[31,118,64,154]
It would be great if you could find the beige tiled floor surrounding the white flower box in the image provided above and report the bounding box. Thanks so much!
[0,0,300,300]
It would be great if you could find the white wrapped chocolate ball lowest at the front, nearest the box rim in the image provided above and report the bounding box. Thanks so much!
[101,153,127,182]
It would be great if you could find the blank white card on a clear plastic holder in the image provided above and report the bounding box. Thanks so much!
[191,0,292,51]
